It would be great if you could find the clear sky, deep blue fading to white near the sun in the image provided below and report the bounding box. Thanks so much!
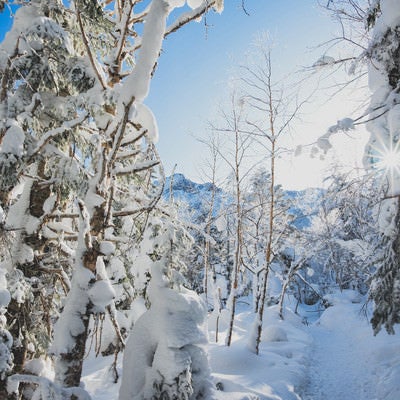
[0,0,366,188]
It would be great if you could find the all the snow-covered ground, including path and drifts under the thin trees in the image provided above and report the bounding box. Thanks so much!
[80,291,400,400]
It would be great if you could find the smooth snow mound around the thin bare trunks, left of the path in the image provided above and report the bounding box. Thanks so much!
[209,306,311,400]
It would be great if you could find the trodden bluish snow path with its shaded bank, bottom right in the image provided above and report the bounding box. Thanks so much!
[302,290,400,400]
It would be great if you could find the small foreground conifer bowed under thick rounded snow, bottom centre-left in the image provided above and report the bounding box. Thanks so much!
[120,277,211,400]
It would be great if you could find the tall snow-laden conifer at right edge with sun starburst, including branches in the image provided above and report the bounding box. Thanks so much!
[320,0,400,333]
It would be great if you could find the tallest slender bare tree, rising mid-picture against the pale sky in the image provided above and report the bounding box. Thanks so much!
[241,42,304,354]
